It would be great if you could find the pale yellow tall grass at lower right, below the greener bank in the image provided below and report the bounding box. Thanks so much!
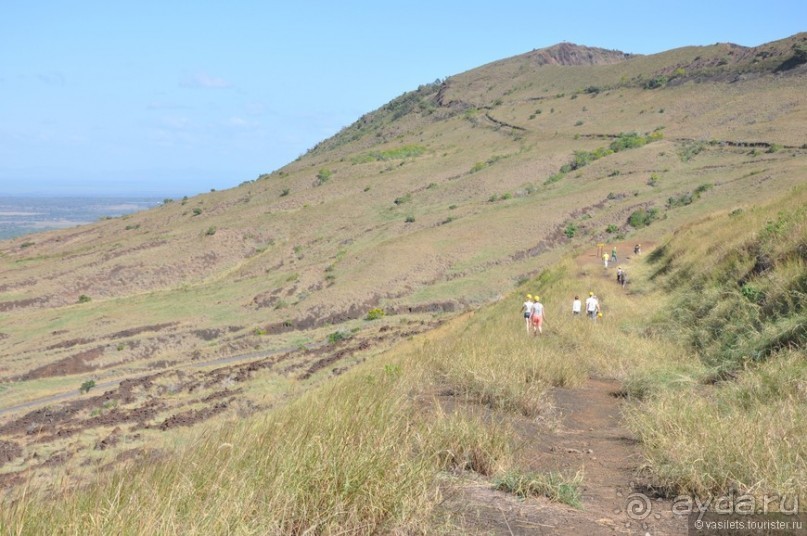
[627,351,807,500]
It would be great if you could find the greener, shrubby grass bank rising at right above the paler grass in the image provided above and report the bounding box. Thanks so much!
[654,188,807,373]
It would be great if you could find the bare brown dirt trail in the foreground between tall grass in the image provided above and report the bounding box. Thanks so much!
[444,379,687,536]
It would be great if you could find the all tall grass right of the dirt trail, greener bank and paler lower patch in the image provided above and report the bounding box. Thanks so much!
[627,187,807,500]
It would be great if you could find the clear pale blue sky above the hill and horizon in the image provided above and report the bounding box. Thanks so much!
[0,0,807,196]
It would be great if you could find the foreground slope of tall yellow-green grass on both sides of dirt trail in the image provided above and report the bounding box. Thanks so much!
[0,187,807,534]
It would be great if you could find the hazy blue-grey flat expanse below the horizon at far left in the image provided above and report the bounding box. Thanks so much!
[0,196,163,240]
